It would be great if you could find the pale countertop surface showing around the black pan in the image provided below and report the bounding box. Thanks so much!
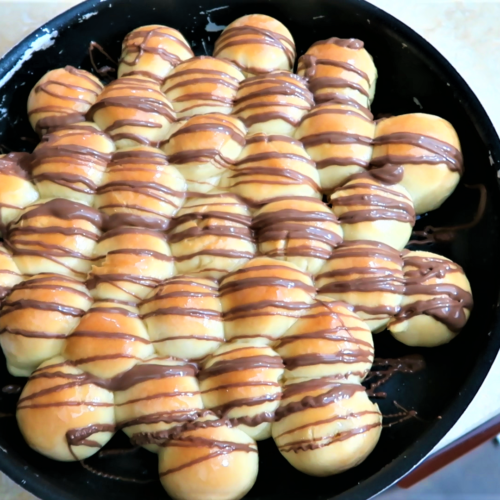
[0,0,500,500]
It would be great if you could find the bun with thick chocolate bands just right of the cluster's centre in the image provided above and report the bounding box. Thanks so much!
[252,198,343,274]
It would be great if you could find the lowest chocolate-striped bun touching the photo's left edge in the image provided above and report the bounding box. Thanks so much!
[0,274,92,377]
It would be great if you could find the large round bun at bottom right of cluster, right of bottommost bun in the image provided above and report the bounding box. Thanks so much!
[272,378,382,477]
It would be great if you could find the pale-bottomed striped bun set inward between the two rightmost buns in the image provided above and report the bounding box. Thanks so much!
[330,167,415,250]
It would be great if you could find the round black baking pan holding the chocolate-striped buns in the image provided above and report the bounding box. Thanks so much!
[0,0,500,500]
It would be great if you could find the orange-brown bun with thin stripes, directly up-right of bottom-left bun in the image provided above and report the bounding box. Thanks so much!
[63,300,153,379]
